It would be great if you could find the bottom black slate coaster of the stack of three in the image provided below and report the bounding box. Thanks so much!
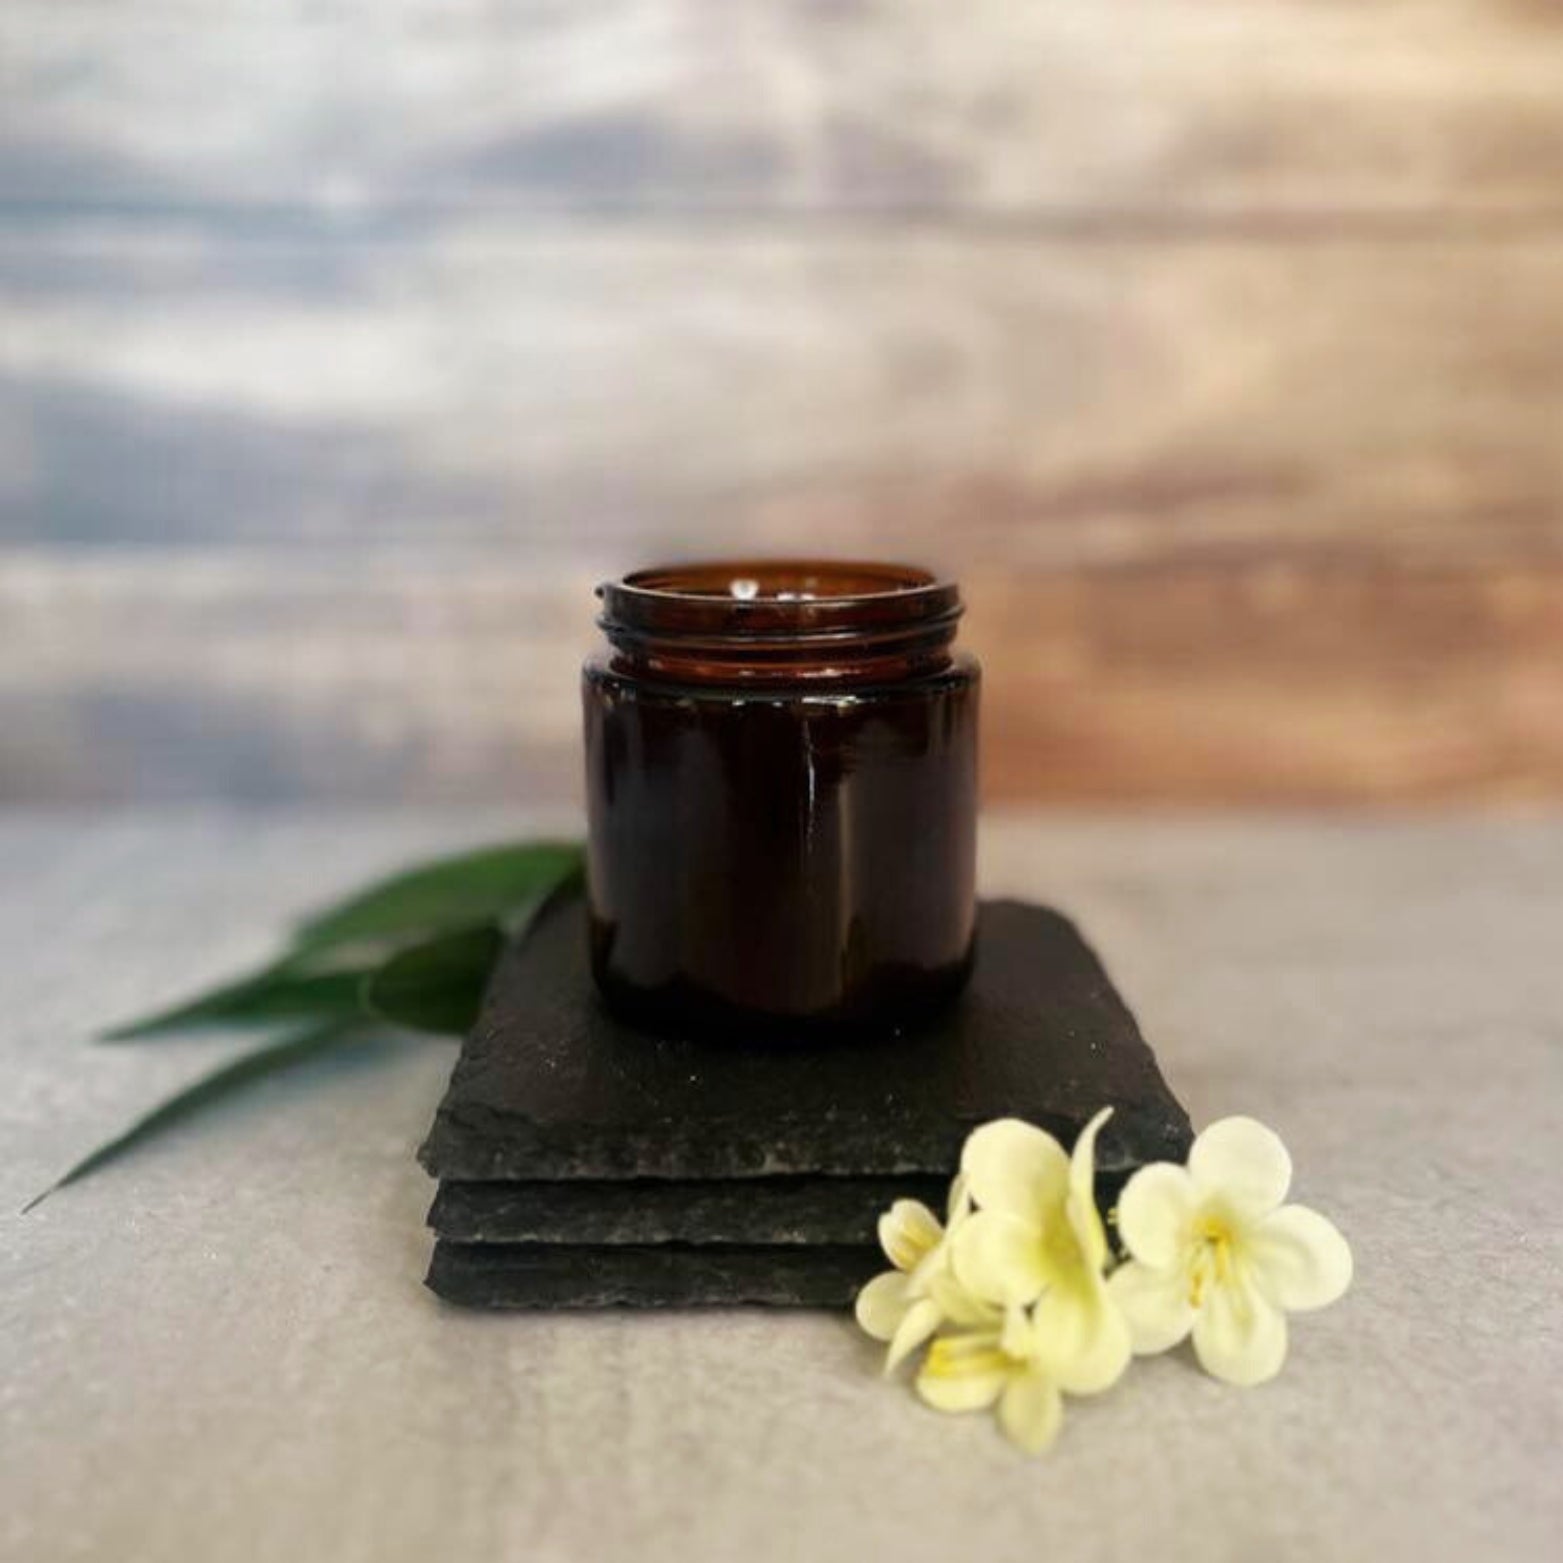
[428,1241,886,1308]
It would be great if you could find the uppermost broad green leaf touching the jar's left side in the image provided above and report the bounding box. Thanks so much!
[294,841,583,957]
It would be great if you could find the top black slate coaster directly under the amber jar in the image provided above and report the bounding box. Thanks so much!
[419,899,1191,1182]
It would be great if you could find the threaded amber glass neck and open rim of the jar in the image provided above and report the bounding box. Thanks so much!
[597,560,961,681]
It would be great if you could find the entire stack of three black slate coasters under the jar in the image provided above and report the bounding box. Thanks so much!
[420,899,1191,1308]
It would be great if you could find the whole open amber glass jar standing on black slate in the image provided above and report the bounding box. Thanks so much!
[583,561,978,1030]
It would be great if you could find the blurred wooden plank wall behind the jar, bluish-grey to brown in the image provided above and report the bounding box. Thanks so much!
[0,9,1563,807]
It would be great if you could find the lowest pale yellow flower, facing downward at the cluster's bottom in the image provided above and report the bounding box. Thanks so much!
[917,1277,1063,1454]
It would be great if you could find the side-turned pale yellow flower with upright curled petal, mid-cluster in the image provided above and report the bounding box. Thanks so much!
[953,1108,1130,1394]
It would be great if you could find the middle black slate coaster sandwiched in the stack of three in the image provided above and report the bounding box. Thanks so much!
[428,1175,949,1247]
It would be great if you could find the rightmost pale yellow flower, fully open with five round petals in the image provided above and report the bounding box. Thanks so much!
[1108,1118,1352,1385]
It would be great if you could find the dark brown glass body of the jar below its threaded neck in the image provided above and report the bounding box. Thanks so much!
[585,658,978,1027]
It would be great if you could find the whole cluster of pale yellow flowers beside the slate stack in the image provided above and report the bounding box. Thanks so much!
[857,1108,1352,1452]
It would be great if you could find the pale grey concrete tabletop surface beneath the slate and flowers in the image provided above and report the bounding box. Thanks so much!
[0,813,1563,1563]
